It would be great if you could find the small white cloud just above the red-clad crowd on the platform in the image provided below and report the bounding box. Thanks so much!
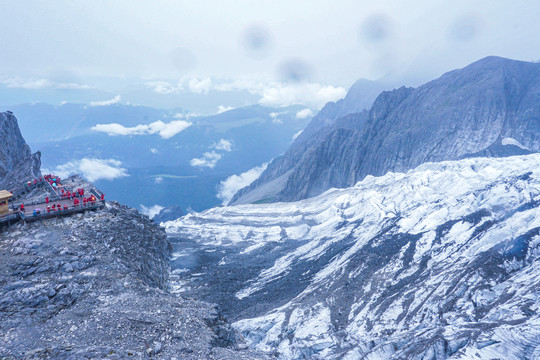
[54,158,129,181]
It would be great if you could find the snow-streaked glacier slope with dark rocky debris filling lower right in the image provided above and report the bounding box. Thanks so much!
[164,154,540,359]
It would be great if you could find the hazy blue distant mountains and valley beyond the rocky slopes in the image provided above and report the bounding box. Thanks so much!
[6,104,311,211]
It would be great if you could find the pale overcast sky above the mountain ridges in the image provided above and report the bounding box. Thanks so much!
[0,0,540,108]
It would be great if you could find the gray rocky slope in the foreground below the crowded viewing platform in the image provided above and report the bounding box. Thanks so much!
[0,198,266,359]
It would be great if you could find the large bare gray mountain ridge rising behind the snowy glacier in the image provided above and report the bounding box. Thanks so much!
[233,57,540,203]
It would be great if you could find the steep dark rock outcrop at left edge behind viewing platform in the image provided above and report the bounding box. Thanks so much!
[0,111,41,192]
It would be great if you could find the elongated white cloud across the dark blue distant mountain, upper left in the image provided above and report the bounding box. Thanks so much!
[91,120,192,139]
